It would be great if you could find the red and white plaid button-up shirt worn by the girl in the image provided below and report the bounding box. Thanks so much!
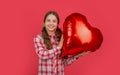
[34,35,77,75]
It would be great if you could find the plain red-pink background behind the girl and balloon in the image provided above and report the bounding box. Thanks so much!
[0,0,120,75]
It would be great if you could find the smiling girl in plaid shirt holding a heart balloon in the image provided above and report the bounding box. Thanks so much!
[34,11,88,75]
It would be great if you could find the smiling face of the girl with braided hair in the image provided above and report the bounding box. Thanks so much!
[45,14,58,32]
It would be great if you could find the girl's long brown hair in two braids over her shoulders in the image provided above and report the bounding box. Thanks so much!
[42,11,62,50]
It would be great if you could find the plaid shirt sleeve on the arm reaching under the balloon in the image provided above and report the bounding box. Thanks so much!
[62,56,78,66]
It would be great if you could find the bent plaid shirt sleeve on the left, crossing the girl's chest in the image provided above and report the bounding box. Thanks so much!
[34,35,61,59]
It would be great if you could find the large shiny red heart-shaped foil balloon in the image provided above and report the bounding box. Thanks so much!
[61,13,103,57]
